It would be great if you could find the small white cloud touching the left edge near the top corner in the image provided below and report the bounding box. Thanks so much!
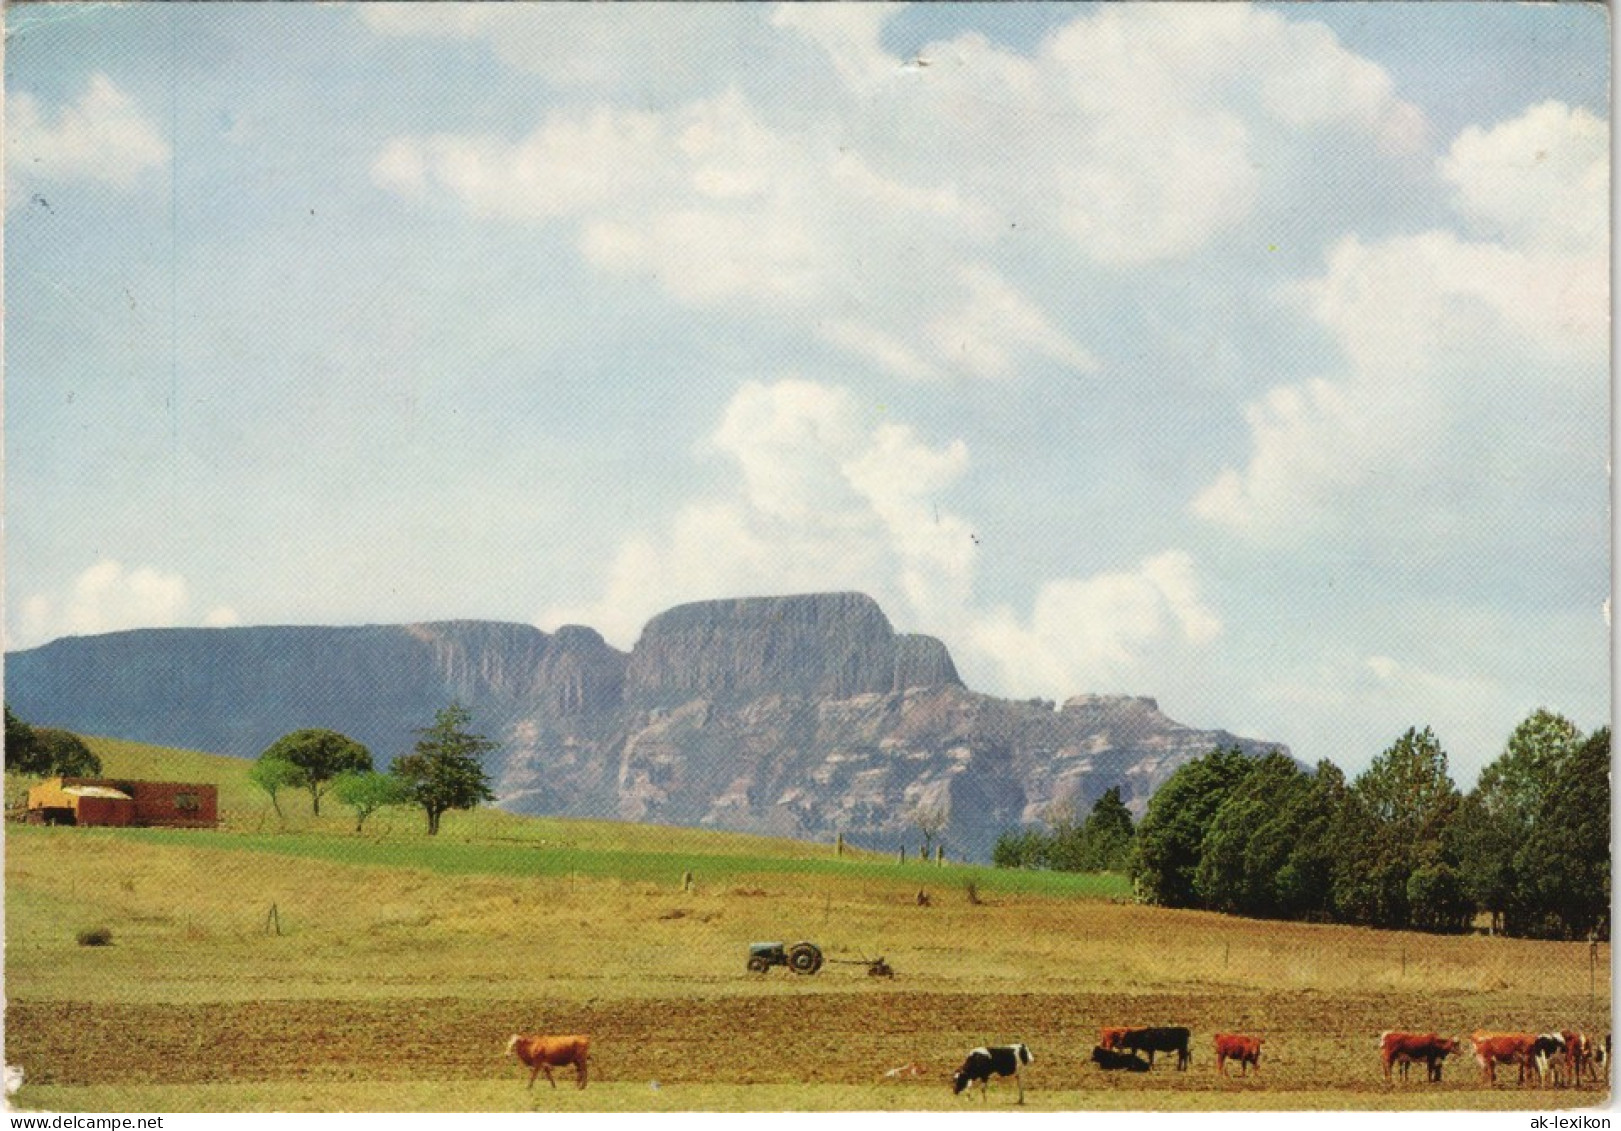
[5,75,169,196]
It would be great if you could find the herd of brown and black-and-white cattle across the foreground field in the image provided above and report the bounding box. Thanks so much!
[507,1026,1610,1103]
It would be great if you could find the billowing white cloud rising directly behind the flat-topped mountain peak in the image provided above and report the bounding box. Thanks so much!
[541,379,1221,695]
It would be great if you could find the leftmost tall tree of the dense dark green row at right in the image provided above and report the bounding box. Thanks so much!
[1131,747,1255,907]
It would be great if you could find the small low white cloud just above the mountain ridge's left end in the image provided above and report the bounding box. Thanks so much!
[21,559,240,647]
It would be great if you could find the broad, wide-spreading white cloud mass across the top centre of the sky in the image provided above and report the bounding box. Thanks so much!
[366,5,1423,381]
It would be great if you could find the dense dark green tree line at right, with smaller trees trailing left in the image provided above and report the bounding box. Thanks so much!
[994,710,1610,938]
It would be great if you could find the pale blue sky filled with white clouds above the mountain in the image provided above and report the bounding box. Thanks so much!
[5,2,1611,787]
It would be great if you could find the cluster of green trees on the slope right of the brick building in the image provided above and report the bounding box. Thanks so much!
[248,703,498,836]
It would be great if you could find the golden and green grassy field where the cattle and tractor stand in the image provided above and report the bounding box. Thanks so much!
[5,740,1610,1112]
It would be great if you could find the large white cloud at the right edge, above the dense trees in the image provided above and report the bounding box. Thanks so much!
[1193,105,1610,546]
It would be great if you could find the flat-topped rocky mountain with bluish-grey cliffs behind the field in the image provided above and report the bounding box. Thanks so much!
[5,593,1277,859]
